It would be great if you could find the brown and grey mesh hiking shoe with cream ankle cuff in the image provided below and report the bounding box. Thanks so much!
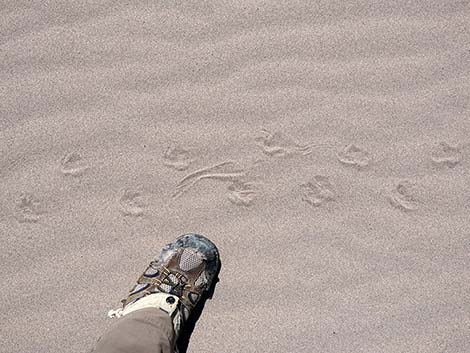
[108,234,220,337]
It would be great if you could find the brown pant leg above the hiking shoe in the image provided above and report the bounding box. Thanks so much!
[92,308,174,353]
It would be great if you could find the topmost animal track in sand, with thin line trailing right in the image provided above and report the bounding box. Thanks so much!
[255,129,331,157]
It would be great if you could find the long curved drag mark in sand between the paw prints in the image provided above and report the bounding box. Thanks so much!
[173,161,245,199]
